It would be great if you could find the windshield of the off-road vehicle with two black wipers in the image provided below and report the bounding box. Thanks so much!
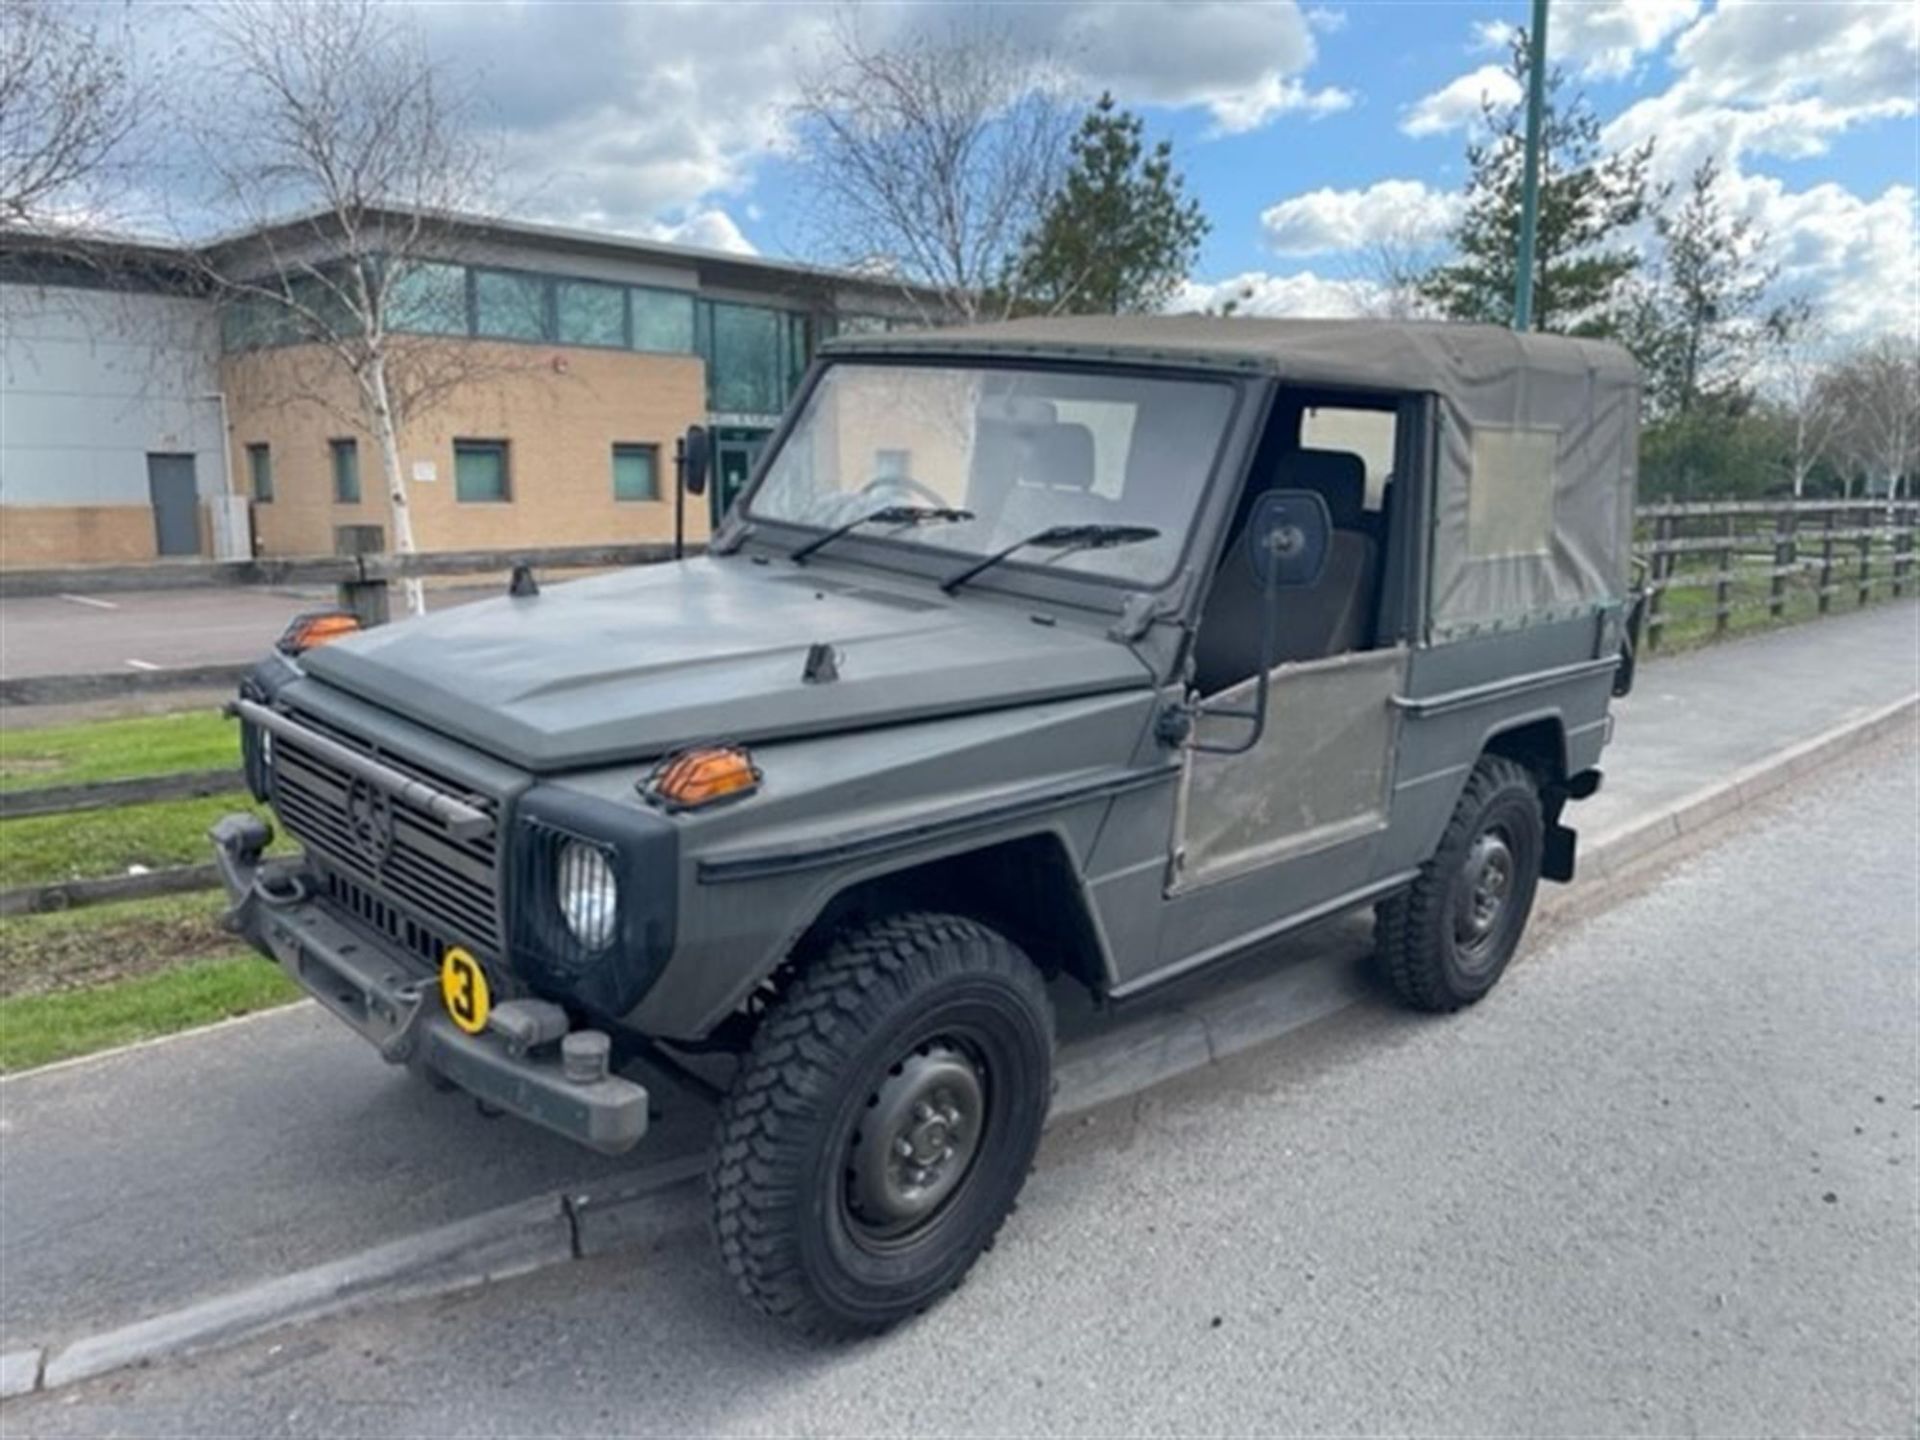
[747,363,1233,586]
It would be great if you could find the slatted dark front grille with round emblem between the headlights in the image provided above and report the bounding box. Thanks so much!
[273,714,501,958]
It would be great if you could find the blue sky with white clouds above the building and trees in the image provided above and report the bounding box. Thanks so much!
[139,0,1920,336]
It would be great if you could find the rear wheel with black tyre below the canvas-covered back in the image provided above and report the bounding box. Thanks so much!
[1375,755,1544,1012]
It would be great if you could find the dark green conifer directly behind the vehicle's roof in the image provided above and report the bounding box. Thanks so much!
[1014,94,1210,315]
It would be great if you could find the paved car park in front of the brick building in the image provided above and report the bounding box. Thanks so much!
[0,584,501,680]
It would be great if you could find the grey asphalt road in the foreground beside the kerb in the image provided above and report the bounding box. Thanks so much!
[4,737,1920,1436]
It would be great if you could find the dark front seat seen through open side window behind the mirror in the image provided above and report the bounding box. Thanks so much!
[1194,449,1380,695]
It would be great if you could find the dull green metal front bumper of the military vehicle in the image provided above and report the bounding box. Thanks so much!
[209,814,647,1154]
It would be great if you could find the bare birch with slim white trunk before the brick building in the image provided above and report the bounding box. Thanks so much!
[181,0,501,614]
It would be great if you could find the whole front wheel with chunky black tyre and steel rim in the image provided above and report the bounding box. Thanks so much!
[708,914,1054,1336]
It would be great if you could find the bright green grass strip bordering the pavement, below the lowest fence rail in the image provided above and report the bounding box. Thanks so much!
[0,954,300,1071]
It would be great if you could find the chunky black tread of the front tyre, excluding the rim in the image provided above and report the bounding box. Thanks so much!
[707,912,1052,1338]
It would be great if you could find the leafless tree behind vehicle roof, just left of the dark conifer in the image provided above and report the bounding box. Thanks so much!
[799,12,1073,319]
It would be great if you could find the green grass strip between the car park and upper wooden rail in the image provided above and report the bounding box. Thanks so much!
[0,710,240,791]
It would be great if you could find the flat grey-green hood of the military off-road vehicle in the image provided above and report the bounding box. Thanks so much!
[291,557,1152,772]
